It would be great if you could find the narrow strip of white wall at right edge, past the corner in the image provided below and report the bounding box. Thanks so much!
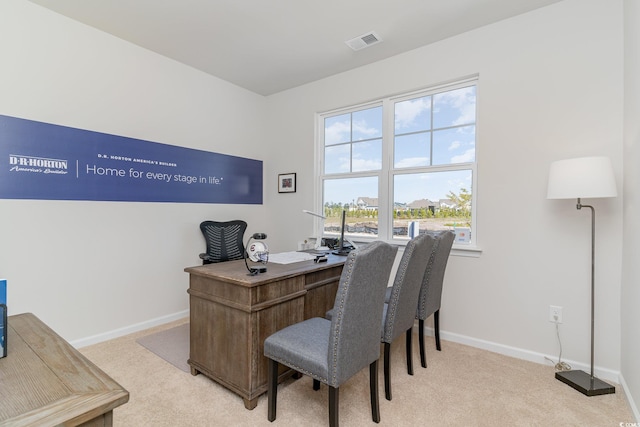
[620,0,640,421]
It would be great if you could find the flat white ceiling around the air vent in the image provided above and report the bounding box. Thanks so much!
[30,0,561,95]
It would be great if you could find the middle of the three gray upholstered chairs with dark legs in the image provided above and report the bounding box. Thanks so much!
[381,234,436,400]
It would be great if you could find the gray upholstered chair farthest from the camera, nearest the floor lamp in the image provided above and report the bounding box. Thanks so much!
[416,230,455,368]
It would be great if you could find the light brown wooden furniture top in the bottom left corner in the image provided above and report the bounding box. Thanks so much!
[0,313,129,427]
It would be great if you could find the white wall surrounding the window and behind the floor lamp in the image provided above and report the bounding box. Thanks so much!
[267,0,623,380]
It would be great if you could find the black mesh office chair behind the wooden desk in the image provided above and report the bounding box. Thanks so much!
[200,220,247,264]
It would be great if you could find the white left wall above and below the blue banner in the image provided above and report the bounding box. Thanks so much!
[0,0,275,343]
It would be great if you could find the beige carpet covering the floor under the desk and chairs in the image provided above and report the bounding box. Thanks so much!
[80,319,635,427]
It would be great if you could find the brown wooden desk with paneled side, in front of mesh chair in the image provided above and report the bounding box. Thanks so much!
[185,255,346,409]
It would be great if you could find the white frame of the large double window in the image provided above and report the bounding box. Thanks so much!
[314,75,481,256]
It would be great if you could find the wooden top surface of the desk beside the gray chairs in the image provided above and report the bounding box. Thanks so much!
[184,254,347,287]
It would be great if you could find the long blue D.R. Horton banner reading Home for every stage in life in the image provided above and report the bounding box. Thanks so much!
[0,115,262,204]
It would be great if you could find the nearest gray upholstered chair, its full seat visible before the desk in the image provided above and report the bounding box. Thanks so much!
[264,241,397,426]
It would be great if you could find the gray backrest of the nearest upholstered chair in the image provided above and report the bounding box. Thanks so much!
[328,241,397,387]
